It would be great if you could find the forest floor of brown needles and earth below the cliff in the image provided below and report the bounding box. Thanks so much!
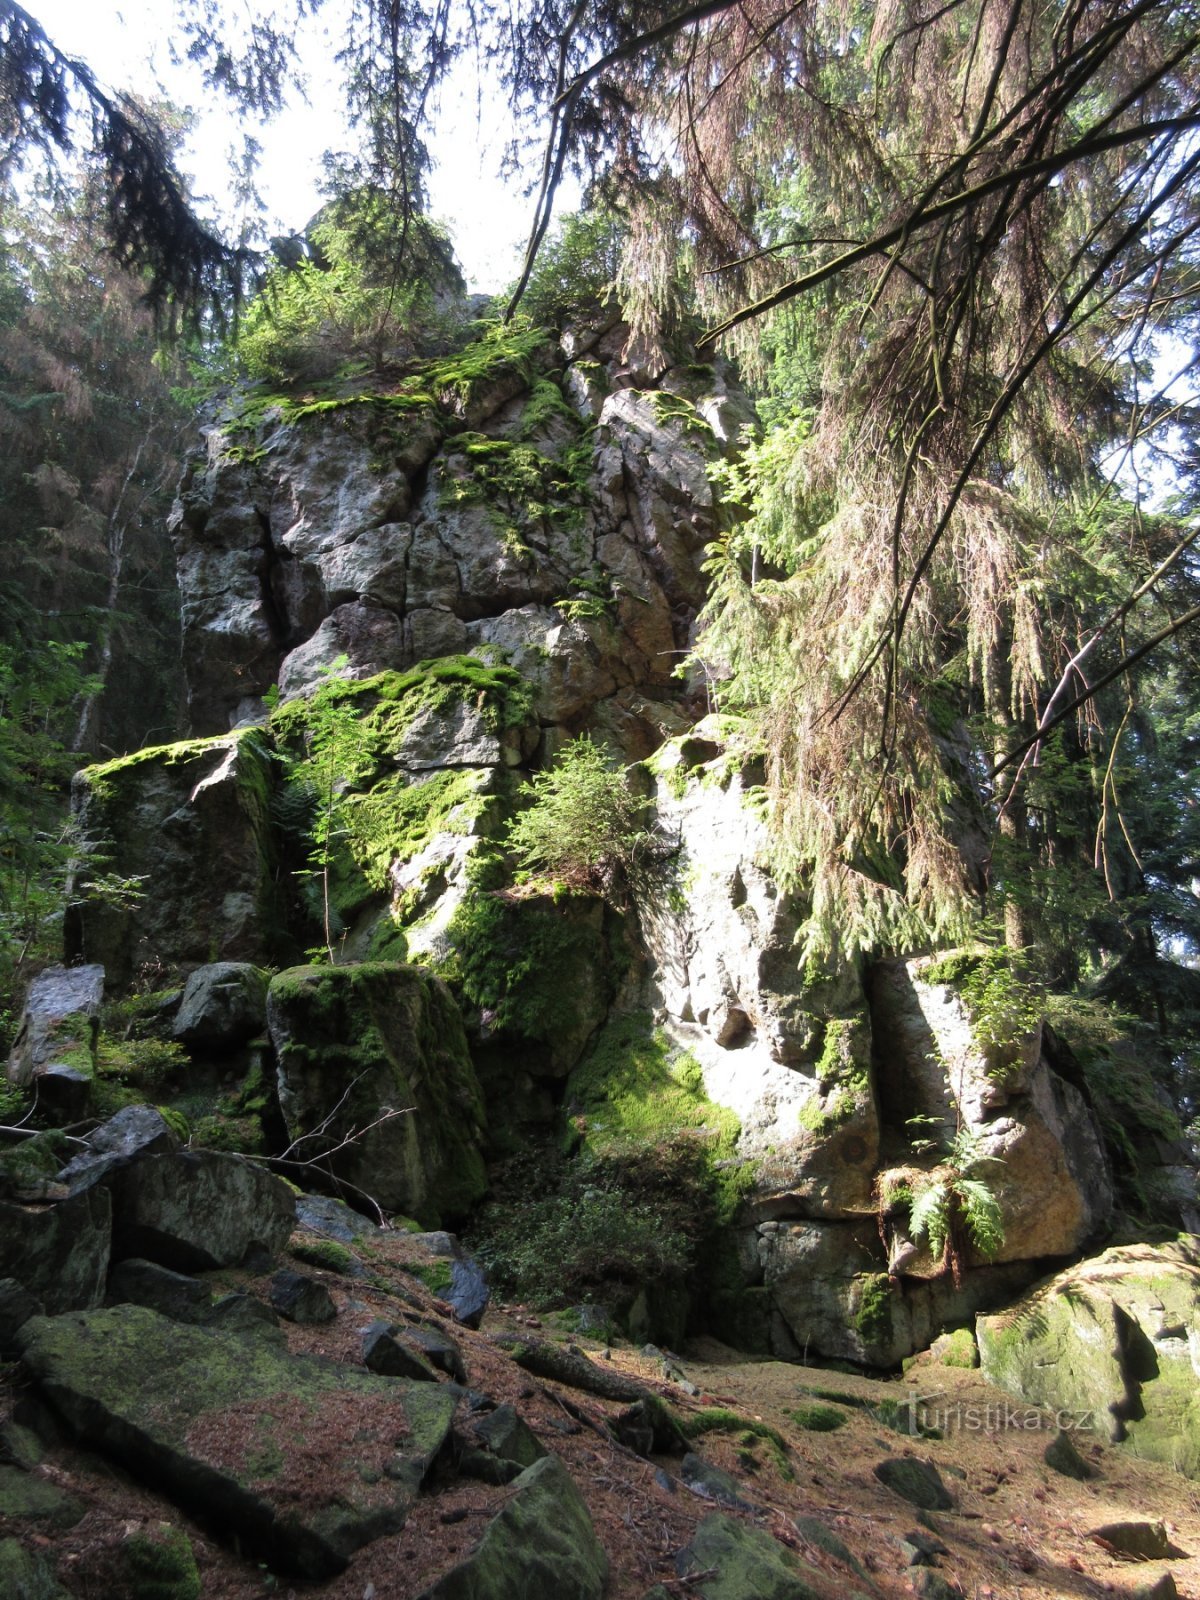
[0,1235,1200,1600]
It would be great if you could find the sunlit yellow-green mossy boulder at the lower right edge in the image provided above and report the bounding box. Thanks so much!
[976,1240,1200,1478]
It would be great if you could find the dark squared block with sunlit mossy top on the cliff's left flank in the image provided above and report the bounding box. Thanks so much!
[66,728,278,989]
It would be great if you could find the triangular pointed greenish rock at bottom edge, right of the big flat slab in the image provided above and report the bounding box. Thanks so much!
[419,1456,608,1600]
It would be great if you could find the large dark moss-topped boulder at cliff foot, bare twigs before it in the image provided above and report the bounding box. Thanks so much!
[267,962,486,1227]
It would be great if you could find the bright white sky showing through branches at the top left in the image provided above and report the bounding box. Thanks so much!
[26,0,578,293]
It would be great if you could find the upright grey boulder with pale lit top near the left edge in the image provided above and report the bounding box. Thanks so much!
[8,963,104,1115]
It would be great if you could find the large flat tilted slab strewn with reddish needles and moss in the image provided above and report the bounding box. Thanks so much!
[22,1306,456,1578]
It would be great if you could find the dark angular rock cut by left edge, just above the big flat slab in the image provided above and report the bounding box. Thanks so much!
[0,1189,112,1314]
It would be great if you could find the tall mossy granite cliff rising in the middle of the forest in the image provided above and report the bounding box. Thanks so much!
[51,308,1190,1365]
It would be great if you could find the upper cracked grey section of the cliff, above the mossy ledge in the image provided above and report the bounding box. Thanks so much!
[173,323,732,754]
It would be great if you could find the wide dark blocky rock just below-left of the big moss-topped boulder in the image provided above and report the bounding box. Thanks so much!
[114,1150,296,1272]
